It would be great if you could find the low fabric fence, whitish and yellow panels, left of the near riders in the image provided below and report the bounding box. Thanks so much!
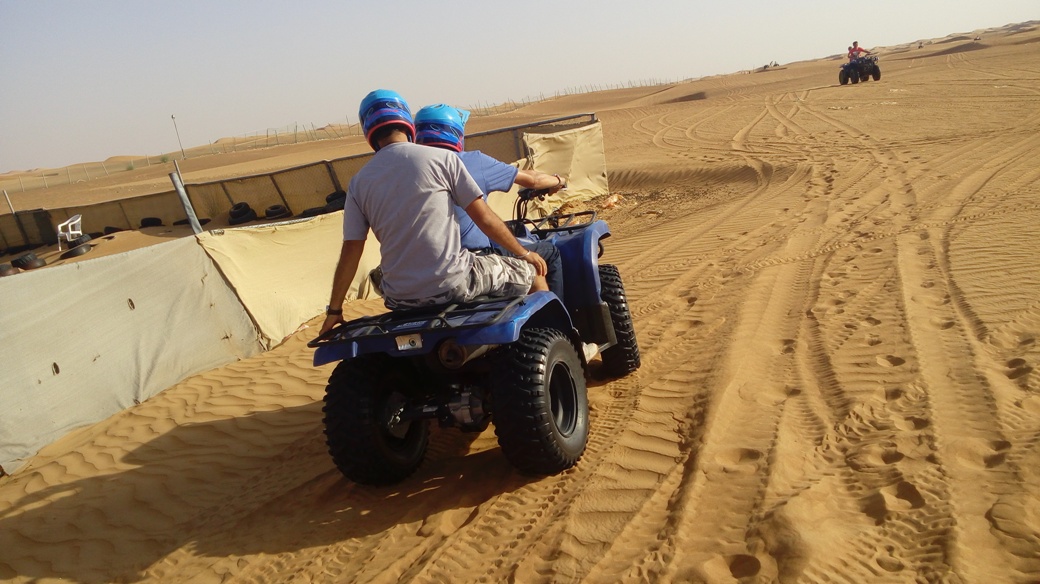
[0,211,379,472]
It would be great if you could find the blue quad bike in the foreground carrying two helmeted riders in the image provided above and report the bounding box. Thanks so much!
[308,189,640,484]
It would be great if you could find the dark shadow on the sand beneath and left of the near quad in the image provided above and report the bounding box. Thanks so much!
[0,403,531,584]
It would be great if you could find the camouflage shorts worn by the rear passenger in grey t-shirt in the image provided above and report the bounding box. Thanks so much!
[383,255,536,310]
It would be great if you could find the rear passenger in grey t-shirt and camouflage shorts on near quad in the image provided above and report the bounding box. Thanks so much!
[321,89,548,334]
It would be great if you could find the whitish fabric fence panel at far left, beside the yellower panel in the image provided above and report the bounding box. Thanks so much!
[0,233,262,472]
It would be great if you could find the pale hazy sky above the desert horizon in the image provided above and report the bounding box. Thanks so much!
[0,0,1040,172]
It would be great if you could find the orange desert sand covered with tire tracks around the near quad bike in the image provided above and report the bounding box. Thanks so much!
[0,23,1040,583]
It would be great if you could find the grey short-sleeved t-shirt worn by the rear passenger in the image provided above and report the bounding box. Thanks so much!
[343,142,483,300]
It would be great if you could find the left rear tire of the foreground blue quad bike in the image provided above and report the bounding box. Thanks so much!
[321,354,430,484]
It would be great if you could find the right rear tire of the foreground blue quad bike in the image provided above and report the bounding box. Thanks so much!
[491,328,589,475]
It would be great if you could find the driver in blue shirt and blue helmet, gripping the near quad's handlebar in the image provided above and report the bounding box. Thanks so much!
[415,104,567,298]
